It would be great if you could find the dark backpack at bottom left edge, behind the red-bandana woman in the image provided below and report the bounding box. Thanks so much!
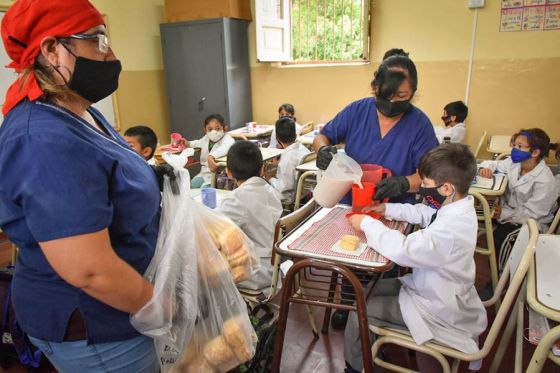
[0,266,42,368]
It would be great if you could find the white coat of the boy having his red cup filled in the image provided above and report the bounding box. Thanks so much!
[361,196,487,353]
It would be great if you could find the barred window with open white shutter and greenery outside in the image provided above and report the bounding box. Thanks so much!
[255,0,371,63]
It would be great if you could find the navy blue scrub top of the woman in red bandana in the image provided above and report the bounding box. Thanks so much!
[0,101,161,343]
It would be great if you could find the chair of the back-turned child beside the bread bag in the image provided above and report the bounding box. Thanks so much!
[238,199,317,310]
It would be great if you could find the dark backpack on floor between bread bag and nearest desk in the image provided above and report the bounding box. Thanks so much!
[231,304,278,373]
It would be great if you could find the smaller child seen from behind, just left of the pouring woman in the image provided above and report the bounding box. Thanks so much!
[269,117,310,203]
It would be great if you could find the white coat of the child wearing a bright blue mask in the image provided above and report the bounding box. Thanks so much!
[480,158,558,232]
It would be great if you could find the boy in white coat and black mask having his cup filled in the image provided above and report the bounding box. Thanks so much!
[344,144,487,370]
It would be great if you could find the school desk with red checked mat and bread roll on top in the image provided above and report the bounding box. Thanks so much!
[272,205,408,372]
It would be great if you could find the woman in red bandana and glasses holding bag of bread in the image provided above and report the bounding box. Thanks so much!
[0,0,160,372]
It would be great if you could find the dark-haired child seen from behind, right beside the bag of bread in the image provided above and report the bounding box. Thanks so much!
[217,141,282,295]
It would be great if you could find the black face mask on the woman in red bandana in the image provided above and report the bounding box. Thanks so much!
[57,43,122,103]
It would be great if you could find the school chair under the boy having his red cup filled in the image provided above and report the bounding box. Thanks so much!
[369,219,539,373]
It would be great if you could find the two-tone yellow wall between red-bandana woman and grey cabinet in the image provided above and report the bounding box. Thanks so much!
[91,0,169,143]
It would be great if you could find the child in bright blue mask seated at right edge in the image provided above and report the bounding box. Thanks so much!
[479,128,558,269]
